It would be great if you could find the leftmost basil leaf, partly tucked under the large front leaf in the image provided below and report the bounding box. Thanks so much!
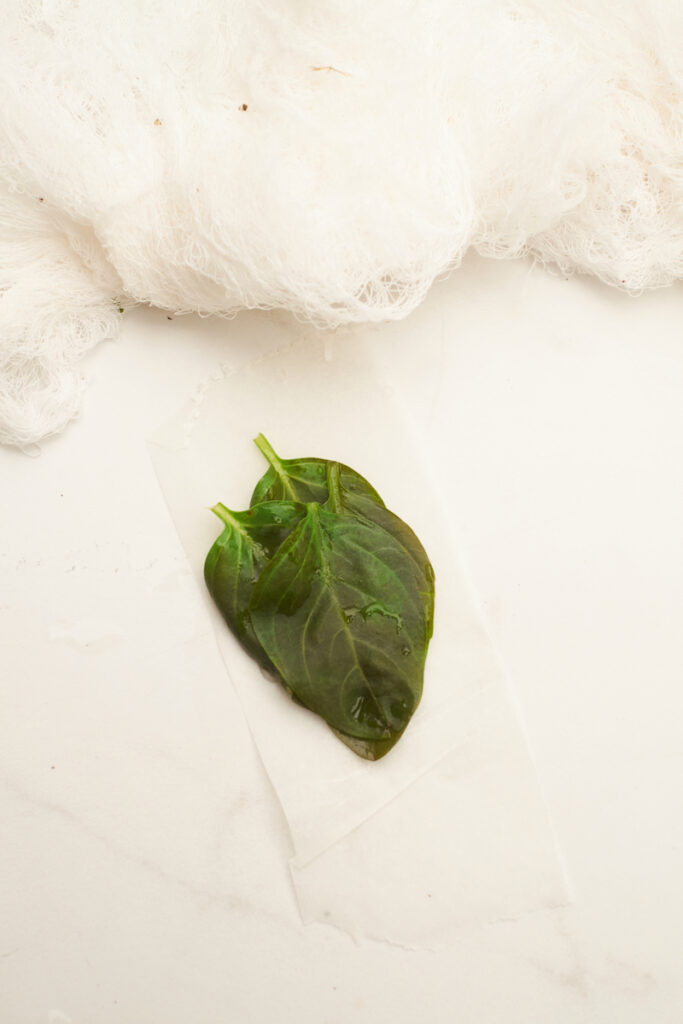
[204,502,306,672]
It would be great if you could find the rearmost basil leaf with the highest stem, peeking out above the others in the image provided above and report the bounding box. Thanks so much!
[250,434,384,505]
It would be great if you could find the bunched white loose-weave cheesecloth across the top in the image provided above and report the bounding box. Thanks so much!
[0,0,683,444]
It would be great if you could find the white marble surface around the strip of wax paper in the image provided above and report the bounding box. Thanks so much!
[0,259,683,1024]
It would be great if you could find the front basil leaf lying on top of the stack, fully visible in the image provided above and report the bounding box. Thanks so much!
[249,503,433,749]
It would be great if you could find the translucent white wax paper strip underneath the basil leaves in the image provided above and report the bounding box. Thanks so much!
[150,325,566,945]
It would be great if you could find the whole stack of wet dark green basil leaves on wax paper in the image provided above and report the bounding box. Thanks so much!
[204,434,434,761]
